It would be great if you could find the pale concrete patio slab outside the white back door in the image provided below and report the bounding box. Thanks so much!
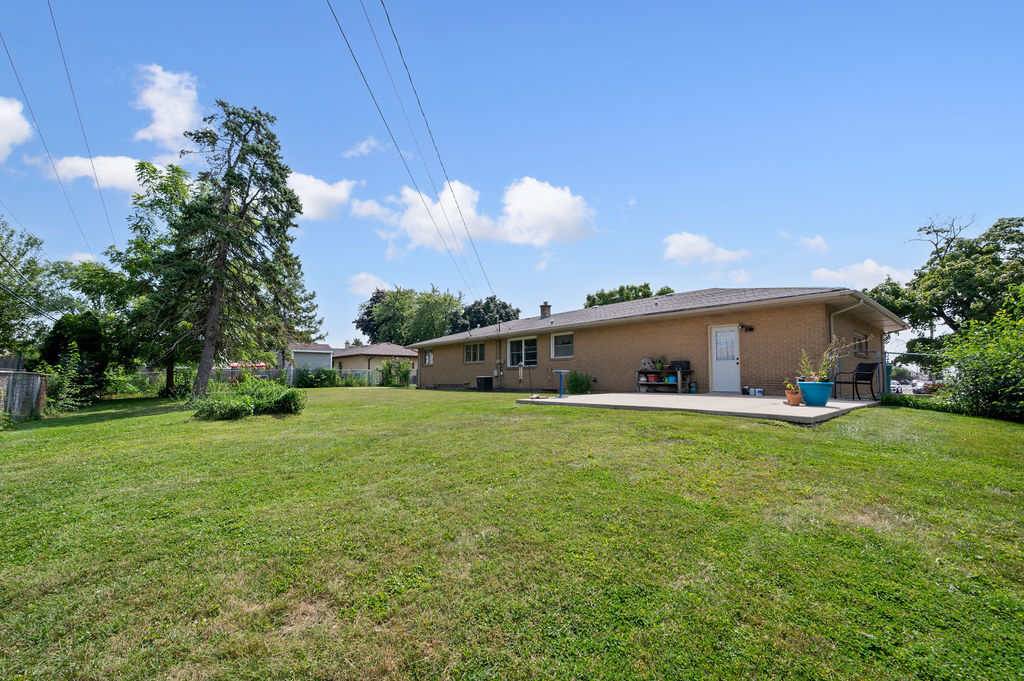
[515,392,880,425]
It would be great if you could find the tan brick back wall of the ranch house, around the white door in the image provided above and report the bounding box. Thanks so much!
[420,304,839,394]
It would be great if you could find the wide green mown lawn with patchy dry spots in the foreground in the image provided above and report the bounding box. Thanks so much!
[0,388,1024,680]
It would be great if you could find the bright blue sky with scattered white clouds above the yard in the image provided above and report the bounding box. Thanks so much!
[0,0,1024,346]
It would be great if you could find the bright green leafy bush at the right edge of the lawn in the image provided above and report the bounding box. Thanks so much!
[945,286,1024,422]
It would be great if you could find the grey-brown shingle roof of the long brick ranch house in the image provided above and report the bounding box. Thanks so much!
[410,287,903,348]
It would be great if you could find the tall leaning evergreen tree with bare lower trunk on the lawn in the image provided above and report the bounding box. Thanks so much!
[177,100,313,397]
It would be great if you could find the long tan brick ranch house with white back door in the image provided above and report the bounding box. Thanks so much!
[411,287,907,394]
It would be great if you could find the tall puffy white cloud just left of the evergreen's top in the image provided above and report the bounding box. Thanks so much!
[135,63,202,153]
